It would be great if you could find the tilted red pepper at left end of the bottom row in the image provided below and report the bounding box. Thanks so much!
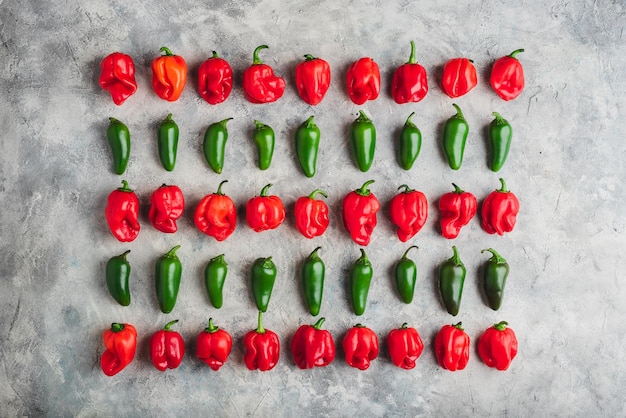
[100,322,137,376]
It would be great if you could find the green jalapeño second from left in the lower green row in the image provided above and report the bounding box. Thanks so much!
[154,245,183,313]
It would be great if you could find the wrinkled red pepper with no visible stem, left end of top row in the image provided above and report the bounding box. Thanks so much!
[98,52,137,106]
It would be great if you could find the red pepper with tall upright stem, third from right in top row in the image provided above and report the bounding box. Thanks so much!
[391,41,428,104]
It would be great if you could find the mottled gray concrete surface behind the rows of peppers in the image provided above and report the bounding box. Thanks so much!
[0,0,626,417]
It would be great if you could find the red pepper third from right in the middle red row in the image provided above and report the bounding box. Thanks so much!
[389,184,428,242]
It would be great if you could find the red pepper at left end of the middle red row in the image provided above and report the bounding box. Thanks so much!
[104,180,141,242]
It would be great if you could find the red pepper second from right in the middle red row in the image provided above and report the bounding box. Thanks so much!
[439,183,478,239]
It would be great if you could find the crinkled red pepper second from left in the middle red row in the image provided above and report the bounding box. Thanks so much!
[148,184,185,233]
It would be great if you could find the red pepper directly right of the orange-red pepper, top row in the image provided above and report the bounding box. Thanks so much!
[198,51,233,105]
